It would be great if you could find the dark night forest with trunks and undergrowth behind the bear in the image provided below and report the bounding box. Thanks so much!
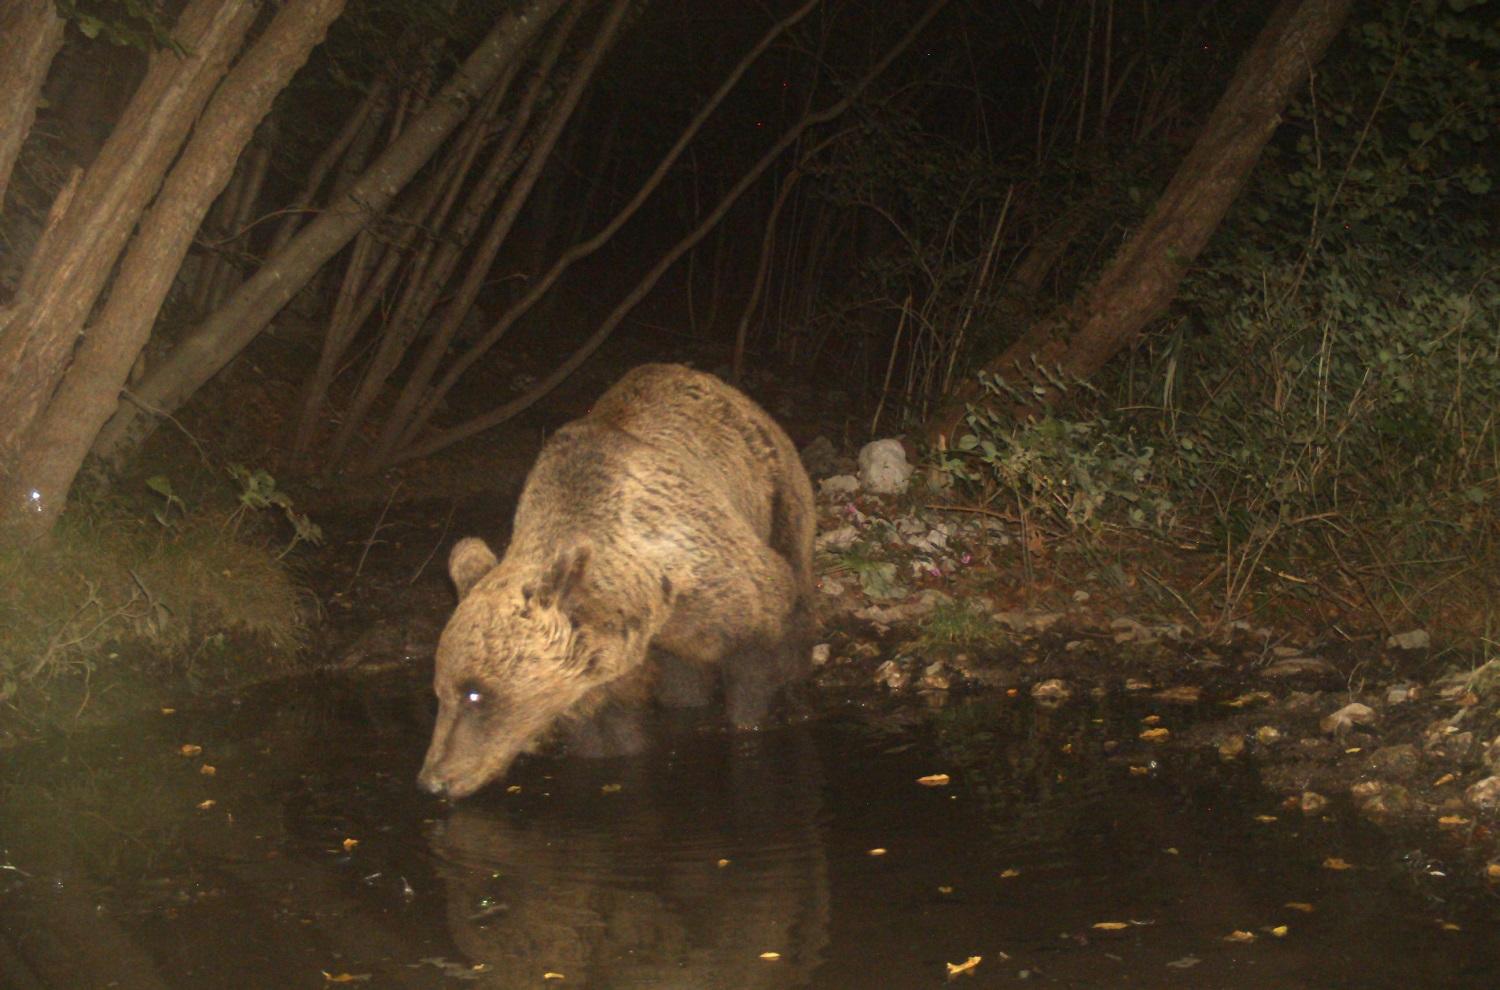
[0,0,1500,711]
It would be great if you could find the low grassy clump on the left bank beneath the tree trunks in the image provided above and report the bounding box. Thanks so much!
[0,468,321,701]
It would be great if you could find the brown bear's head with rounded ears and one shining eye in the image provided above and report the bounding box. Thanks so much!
[417,537,648,798]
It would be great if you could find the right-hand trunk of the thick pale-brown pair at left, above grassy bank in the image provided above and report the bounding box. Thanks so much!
[0,0,345,537]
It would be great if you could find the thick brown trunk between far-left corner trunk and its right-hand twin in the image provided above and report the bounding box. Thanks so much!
[0,0,255,531]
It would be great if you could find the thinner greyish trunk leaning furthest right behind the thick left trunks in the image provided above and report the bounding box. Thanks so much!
[95,0,564,468]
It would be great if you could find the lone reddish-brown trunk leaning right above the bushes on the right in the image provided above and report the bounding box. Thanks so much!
[929,0,1353,446]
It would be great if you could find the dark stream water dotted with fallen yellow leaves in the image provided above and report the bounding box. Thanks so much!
[0,678,1500,989]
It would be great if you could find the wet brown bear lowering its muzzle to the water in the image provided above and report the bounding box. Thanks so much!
[419,365,816,798]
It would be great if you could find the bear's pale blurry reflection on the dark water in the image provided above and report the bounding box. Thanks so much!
[432,728,828,990]
